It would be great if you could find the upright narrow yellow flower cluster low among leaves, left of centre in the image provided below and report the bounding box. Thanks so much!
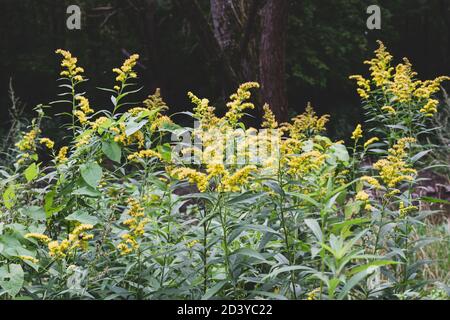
[117,198,150,255]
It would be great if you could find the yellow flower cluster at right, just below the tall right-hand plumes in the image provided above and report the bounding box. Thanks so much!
[373,138,417,188]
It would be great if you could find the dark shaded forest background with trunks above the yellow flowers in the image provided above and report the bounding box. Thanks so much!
[0,0,450,138]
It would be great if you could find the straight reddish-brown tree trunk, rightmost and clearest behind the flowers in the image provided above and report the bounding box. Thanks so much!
[259,0,288,122]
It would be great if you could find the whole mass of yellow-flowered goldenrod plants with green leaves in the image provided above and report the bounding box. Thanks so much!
[0,44,448,300]
